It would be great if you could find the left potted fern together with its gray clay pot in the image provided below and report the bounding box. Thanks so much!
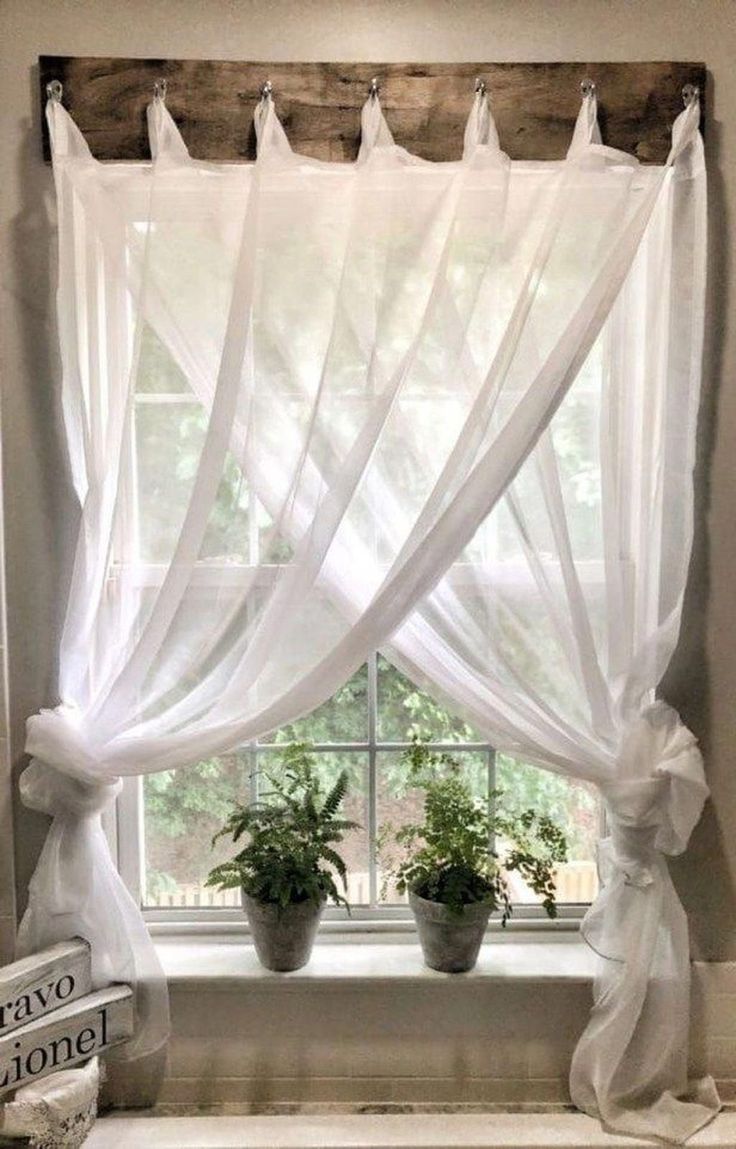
[207,743,357,971]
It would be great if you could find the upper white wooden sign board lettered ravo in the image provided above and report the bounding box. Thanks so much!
[0,938,92,1039]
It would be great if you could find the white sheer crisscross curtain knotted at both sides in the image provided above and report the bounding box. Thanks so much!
[21,81,718,1140]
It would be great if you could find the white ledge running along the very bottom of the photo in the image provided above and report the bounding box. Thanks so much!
[85,1113,736,1149]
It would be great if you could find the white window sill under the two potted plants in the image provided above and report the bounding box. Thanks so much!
[156,932,596,990]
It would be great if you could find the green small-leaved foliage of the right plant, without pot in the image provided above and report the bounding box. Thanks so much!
[379,739,567,926]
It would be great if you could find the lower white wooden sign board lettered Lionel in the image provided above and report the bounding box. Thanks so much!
[0,986,133,1097]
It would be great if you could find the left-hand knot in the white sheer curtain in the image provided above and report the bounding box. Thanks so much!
[20,704,123,817]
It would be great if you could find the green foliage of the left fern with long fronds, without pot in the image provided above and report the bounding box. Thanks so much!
[207,742,358,909]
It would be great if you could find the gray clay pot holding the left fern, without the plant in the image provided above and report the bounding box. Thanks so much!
[242,889,325,973]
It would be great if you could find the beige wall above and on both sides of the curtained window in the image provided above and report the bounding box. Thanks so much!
[0,0,736,959]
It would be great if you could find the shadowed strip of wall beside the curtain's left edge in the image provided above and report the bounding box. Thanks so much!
[2,67,77,913]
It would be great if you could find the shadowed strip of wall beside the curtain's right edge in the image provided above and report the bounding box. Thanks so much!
[661,72,736,961]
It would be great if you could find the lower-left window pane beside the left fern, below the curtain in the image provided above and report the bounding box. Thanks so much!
[144,751,251,907]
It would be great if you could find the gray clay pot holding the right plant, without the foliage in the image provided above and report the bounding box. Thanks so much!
[409,890,490,973]
